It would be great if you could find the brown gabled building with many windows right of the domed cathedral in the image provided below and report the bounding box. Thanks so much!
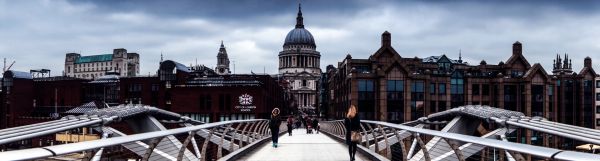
[326,31,597,147]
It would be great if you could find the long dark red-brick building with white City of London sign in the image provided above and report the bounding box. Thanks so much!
[0,43,290,129]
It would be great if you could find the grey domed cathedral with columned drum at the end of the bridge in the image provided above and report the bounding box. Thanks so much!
[279,3,321,114]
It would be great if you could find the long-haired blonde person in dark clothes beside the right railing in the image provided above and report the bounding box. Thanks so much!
[344,105,360,161]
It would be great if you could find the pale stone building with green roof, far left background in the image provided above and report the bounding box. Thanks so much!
[64,48,140,79]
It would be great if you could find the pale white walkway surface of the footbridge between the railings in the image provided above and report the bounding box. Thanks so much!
[240,129,368,161]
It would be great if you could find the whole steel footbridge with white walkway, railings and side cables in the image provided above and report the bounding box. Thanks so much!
[0,105,600,161]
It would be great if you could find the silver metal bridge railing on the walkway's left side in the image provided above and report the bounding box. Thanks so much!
[0,119,278,160]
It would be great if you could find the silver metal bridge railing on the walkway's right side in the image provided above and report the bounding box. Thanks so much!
[321,120,600,161]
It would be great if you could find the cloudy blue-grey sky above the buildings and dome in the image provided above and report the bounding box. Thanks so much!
[0,0,600,75]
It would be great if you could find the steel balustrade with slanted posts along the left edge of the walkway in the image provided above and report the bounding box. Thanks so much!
[0,119,270,160]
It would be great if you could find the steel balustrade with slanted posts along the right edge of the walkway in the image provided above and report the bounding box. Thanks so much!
[321,120,600,161]
